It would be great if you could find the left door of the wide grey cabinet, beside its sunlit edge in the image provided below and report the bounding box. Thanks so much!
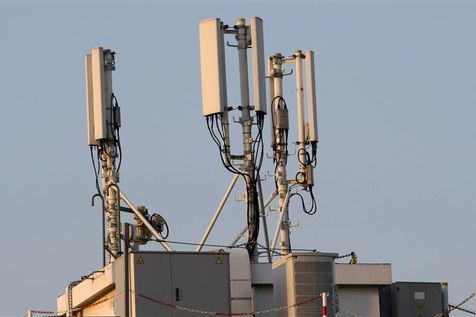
[131,252,173,317]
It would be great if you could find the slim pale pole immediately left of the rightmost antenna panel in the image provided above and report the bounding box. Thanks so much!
[294,50,307,183]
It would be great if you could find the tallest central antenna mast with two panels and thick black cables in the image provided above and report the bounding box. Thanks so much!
[197,17,268,261]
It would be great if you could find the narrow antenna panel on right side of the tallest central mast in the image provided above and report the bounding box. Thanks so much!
[250,17,266,114]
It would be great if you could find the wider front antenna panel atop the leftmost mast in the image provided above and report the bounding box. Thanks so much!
[91,47,112,140]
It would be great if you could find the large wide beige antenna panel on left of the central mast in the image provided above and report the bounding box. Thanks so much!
[200,18,227,117]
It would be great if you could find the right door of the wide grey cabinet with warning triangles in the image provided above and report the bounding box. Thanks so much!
[171,253,230,317]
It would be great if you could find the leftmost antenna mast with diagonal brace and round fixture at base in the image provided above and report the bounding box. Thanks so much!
[85,47,172,264]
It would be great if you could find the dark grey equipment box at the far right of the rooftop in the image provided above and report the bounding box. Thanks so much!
[380,282,445,317]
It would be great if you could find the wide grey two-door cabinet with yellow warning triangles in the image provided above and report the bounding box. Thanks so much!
[130,252,231,317]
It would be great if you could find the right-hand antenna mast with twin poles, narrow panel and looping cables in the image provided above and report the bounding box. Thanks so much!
[268,50,318,256]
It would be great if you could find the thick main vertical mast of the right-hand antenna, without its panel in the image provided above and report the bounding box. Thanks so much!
[269,53,291,255]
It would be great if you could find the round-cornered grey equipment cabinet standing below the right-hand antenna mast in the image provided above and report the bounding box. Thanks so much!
[273,252,338,317]
